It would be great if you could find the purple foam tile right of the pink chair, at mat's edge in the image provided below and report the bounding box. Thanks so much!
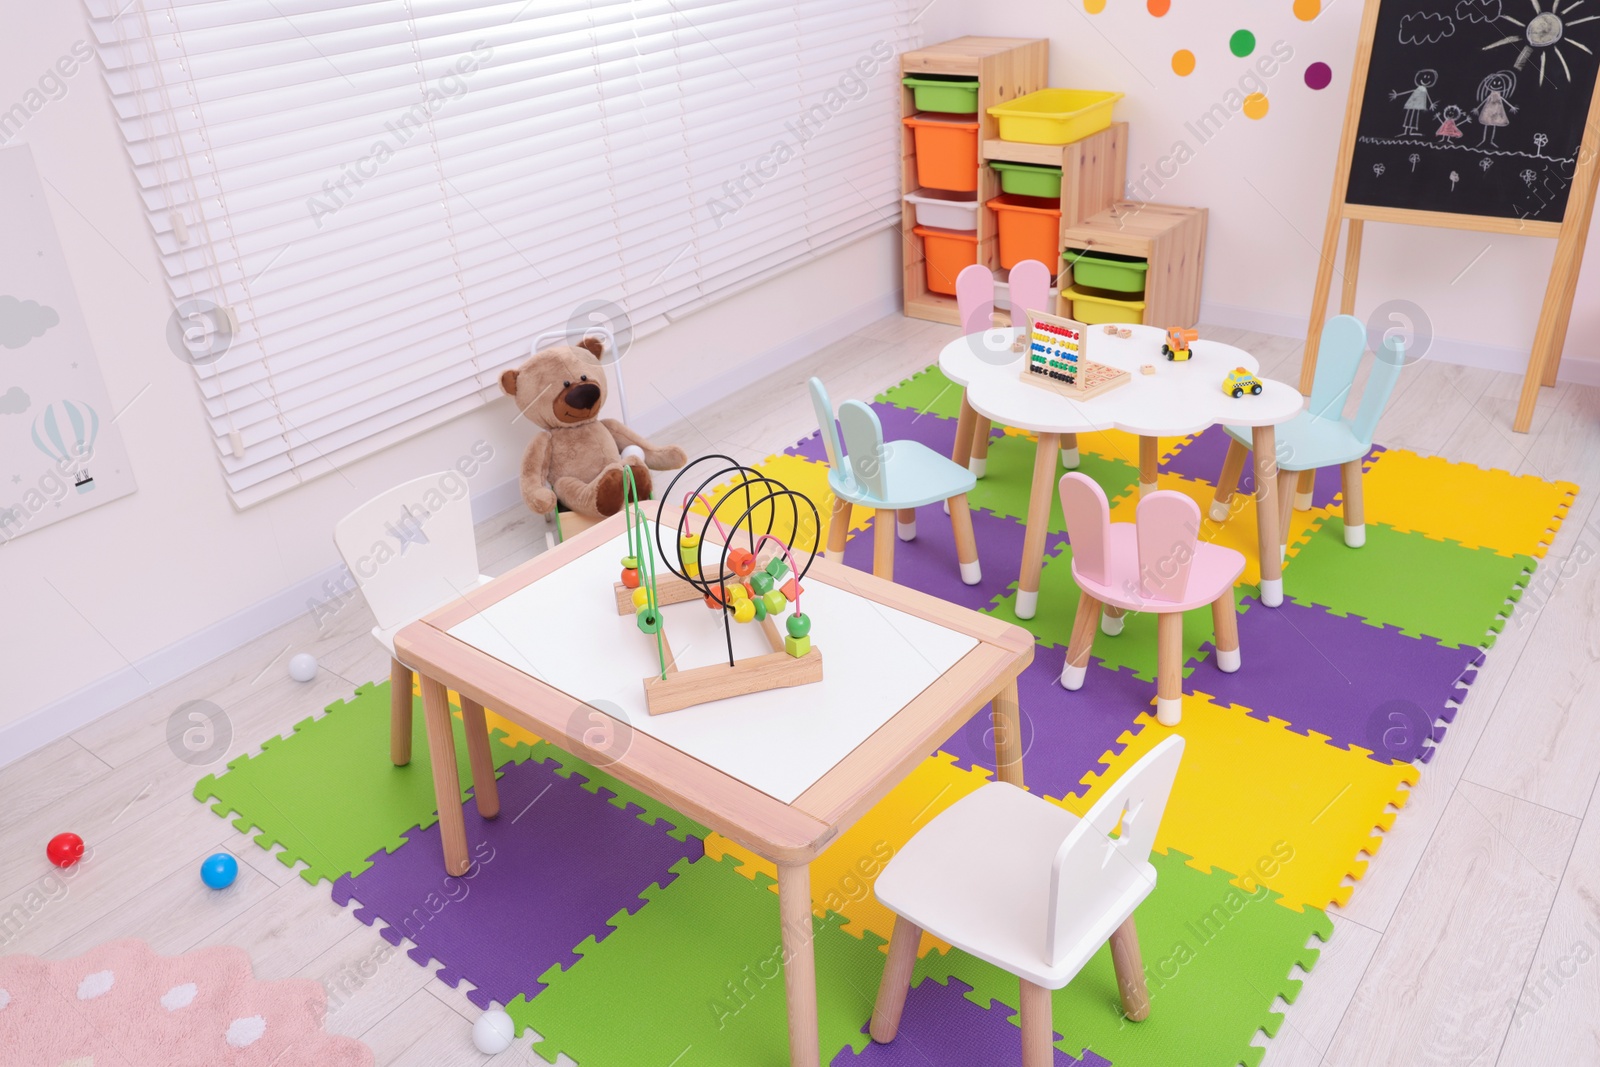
[1184,597,1483,763]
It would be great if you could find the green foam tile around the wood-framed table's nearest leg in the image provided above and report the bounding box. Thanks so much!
[506,857,885,1067]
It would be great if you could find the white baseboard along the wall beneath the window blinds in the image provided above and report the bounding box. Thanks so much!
[0,291,901,766]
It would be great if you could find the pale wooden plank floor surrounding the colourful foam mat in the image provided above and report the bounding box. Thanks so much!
[0,317,1600,1067]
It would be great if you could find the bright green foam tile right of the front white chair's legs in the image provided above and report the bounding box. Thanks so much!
[910,849,1333,1067]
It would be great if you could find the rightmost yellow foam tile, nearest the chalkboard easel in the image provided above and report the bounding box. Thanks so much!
[1363,448,1578,558]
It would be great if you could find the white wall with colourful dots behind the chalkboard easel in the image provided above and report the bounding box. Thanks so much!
[922,0,1600,375]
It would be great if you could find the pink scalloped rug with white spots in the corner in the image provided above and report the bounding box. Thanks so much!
[0,939,373,1067]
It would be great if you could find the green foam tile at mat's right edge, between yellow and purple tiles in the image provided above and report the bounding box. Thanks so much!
[1260,517,1538,648]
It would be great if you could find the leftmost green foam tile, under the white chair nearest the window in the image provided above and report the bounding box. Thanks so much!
[194,681,533,885]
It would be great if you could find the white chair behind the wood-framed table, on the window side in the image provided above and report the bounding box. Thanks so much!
[333,470,499,819]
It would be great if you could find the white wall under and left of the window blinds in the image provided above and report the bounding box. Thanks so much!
[0,0,898,739]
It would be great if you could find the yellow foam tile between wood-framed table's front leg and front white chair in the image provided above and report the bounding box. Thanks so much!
[706,752,989,955]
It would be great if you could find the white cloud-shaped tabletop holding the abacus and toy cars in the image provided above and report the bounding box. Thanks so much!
[939,326,1306,437]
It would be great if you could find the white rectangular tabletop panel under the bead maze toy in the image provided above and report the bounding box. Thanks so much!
[450,525,978,803]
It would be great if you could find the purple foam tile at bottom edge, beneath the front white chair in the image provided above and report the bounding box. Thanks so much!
[832,977,1112,1067]
